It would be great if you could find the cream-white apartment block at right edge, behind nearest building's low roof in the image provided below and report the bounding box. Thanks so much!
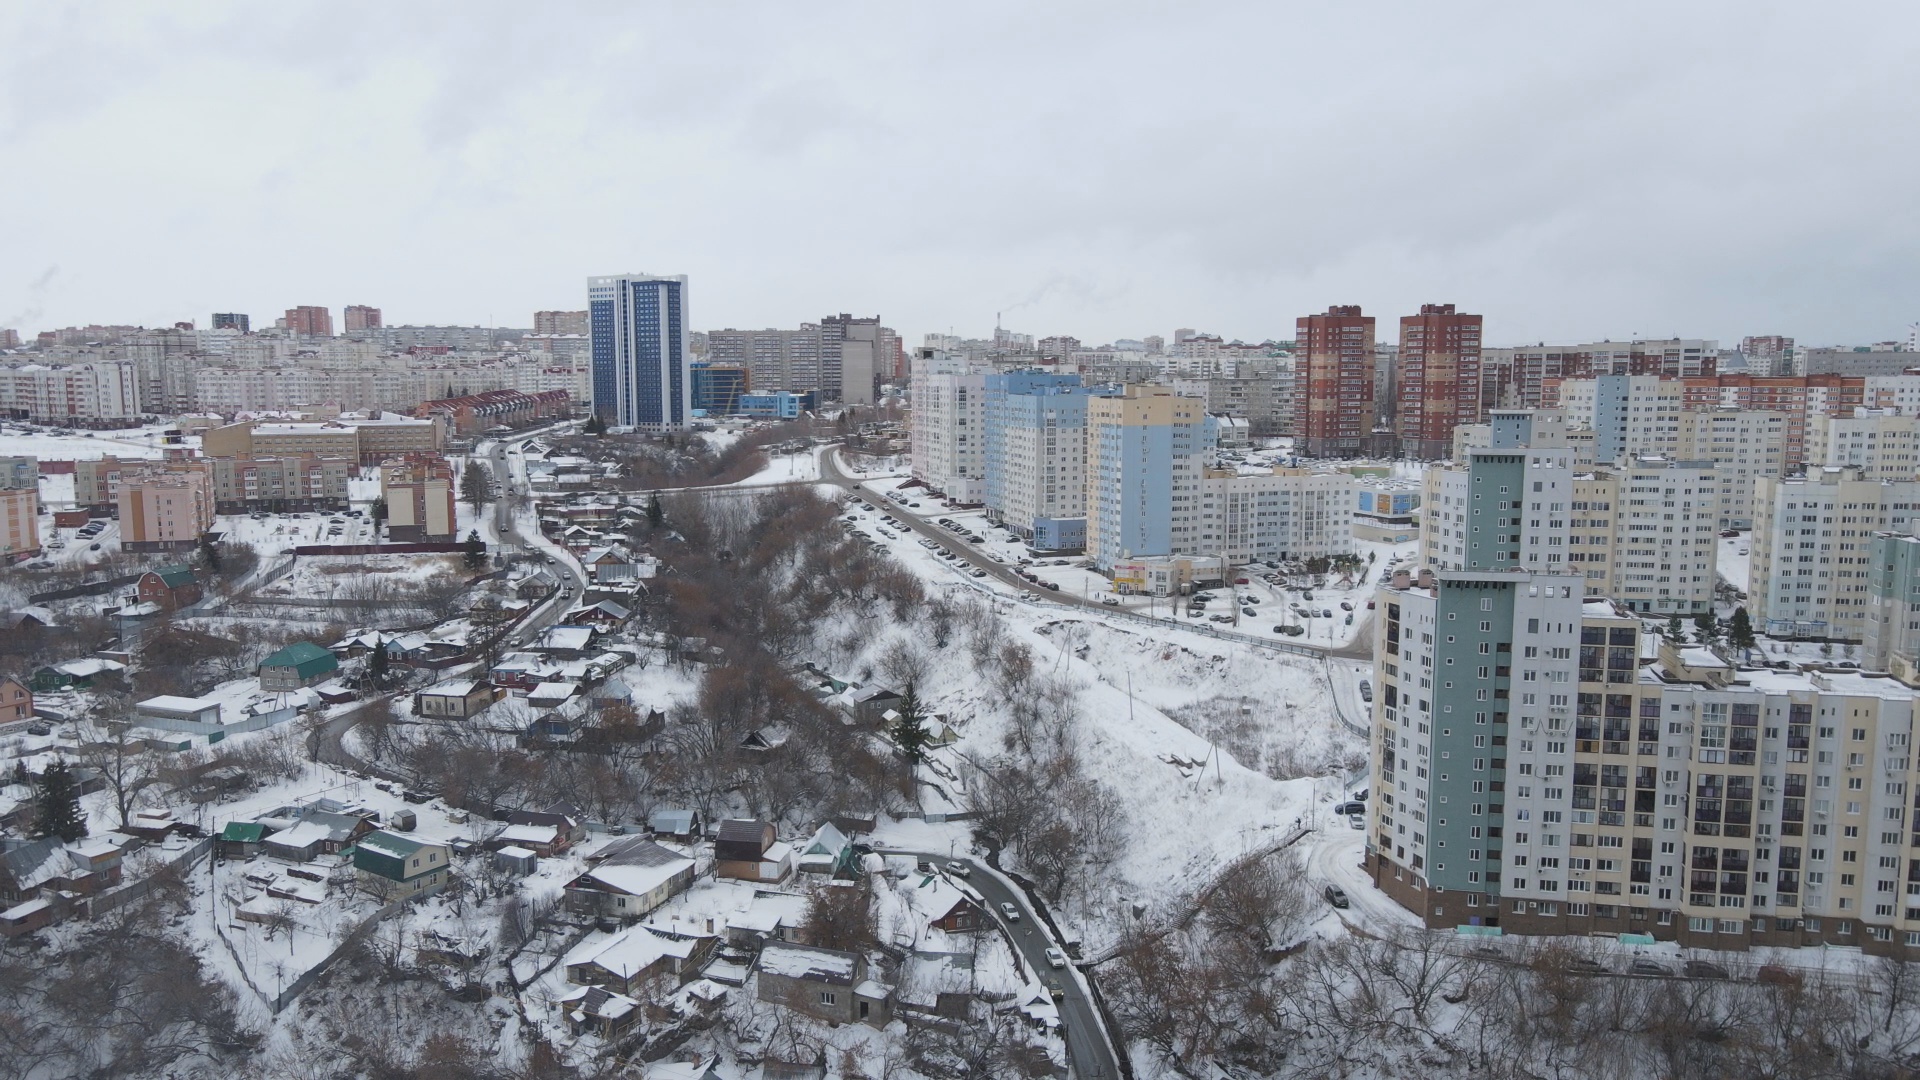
[1749,465,1920,642]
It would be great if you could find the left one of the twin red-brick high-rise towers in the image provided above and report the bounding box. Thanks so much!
[1294,306,1375,457]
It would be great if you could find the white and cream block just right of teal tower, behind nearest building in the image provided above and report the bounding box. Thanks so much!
[1548,457,1720,615]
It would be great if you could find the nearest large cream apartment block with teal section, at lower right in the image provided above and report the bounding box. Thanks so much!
[1367,571,1920,955]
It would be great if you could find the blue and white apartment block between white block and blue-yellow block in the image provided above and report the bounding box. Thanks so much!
[981,371,1114,552]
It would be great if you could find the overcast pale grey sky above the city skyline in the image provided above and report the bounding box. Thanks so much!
[0,0,1920,344]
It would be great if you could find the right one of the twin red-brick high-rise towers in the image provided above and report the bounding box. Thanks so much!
[1396,304,1486,461]
